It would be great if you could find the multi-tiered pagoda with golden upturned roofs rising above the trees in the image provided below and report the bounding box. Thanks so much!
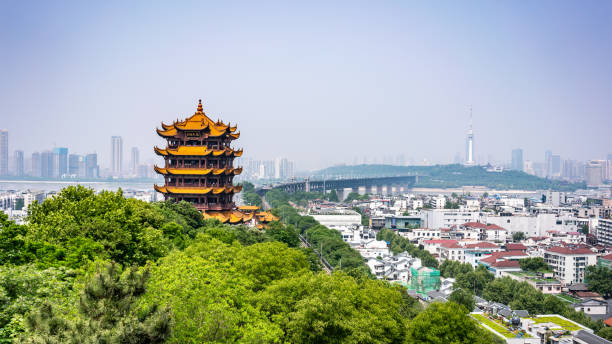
[154,100,274,224]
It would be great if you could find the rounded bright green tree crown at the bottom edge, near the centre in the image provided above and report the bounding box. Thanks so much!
[258,273,405,343]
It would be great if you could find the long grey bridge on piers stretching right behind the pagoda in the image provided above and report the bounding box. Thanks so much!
[257,176,418,199]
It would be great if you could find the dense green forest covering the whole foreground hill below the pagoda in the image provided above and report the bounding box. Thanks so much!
[0,187,496,343]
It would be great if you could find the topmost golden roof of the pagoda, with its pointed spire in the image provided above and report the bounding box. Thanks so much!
[157,99,240,139]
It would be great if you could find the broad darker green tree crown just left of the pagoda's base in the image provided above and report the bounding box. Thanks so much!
[27,186,173,265]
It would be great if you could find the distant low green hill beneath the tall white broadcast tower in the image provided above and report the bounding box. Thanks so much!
[314,164,586,191]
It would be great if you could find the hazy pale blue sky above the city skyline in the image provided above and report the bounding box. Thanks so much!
[0,0,612,169]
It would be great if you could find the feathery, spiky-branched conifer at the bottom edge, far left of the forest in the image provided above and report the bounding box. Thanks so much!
[19,263,170,344]
